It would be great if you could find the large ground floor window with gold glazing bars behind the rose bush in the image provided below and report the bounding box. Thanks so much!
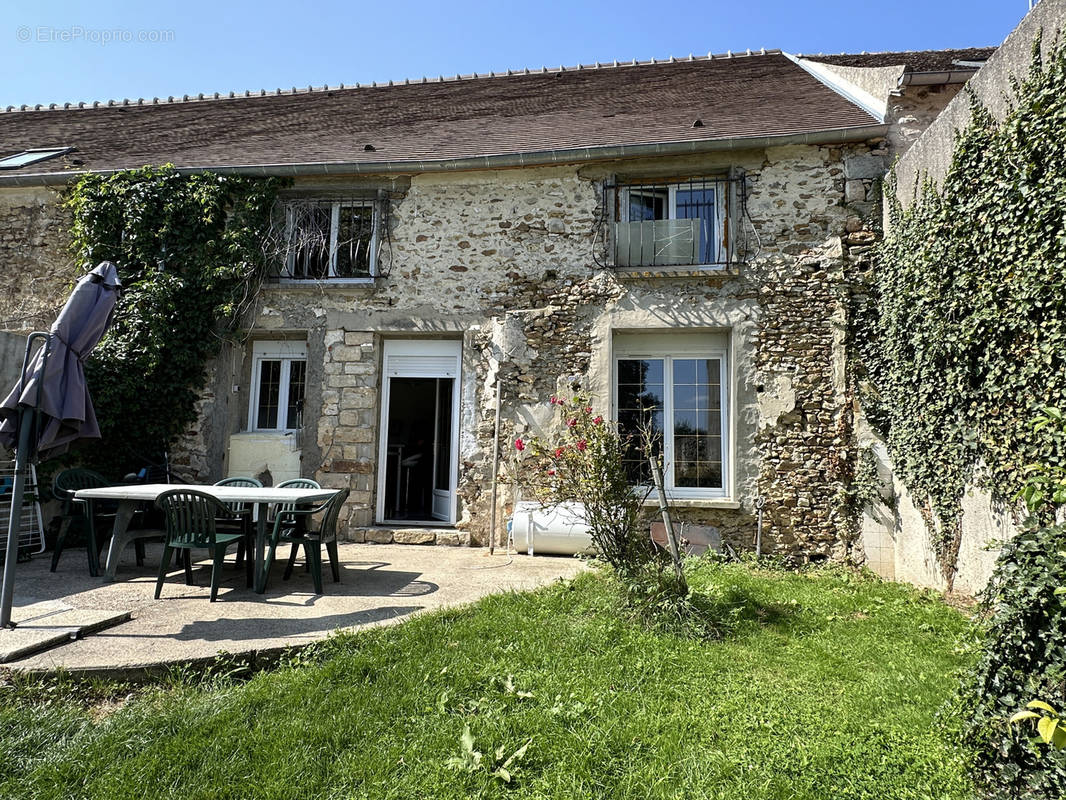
[614,333,729,497]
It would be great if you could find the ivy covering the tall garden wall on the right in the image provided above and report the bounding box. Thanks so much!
[853,41,1066,579]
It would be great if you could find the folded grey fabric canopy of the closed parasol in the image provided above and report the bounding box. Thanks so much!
[0,261,122,459]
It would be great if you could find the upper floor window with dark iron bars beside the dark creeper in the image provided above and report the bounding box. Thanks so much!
[281,198,379,281]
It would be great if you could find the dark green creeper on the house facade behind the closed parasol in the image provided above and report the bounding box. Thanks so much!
[65,166,281,474]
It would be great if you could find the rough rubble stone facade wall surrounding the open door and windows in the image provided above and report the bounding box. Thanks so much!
[229,142,886,559]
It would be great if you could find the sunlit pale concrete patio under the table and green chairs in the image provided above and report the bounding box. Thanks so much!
[0,544,584,675]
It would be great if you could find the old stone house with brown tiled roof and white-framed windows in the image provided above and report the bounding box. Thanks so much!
[0,49,990,566]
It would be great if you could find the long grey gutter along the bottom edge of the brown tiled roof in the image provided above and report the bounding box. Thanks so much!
[0,124,888,187]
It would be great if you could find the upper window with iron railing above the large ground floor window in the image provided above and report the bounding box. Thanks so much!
[603,177,744,268]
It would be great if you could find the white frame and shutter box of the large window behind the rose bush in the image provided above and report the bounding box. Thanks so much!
[611,332,732,499]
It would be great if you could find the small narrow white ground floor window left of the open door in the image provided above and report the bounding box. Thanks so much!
[248,341,307,431]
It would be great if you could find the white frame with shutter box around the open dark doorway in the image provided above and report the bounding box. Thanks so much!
[374,339,463,525]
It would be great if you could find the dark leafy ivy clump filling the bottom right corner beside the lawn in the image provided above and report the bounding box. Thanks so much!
[957,409,1066,798]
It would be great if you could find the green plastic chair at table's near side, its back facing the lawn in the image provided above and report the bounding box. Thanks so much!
[156,489,253,603]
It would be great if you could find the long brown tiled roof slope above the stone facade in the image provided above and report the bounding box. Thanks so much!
[0,51,877,179]
